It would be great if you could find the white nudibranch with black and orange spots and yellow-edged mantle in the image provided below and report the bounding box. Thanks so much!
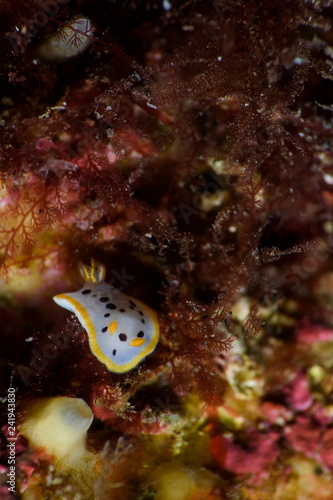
[53,259,159,373]
